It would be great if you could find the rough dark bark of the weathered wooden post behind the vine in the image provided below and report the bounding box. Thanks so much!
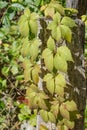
[38,18,86,130]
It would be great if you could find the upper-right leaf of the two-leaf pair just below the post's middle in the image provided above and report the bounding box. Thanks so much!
[55,74,66,87]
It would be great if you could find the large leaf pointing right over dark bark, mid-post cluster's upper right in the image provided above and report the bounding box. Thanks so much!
[57,46,73,61]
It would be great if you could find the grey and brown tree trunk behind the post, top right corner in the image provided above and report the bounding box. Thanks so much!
[66,0,87,17]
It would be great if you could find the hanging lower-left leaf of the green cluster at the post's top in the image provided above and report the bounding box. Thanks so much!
[52,26,61,41]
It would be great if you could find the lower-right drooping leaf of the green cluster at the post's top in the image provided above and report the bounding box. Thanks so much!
[60,25,72,43]
